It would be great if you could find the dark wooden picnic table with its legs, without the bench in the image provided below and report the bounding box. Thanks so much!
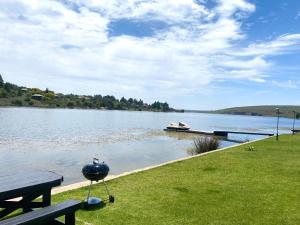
[0,171,63,219]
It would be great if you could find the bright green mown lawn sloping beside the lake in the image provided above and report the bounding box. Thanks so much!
[54,135,300,225]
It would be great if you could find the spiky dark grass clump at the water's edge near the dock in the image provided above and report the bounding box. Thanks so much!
[189,136,220,155]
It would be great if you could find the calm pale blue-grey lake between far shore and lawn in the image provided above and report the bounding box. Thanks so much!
[0,108,293,185]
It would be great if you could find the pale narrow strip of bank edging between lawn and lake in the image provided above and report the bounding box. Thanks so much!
[51,137,272,195]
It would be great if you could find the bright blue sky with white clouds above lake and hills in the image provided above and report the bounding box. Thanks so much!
[0,0,300,110]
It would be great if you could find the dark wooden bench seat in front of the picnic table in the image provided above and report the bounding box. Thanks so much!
[0,200,82,225]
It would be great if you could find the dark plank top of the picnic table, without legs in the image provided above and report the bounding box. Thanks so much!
[0,171,63,200]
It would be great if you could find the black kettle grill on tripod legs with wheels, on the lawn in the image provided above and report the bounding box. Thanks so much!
[82,158,115,207]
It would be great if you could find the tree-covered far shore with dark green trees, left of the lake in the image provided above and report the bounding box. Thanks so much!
[0,74,180,112]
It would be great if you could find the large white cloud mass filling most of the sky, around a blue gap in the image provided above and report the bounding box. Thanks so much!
[0,0,300,101]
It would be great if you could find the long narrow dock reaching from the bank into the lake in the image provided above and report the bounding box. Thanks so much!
[164,129,274,137]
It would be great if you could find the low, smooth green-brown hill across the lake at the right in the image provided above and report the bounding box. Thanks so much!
[190,105,300,118]
